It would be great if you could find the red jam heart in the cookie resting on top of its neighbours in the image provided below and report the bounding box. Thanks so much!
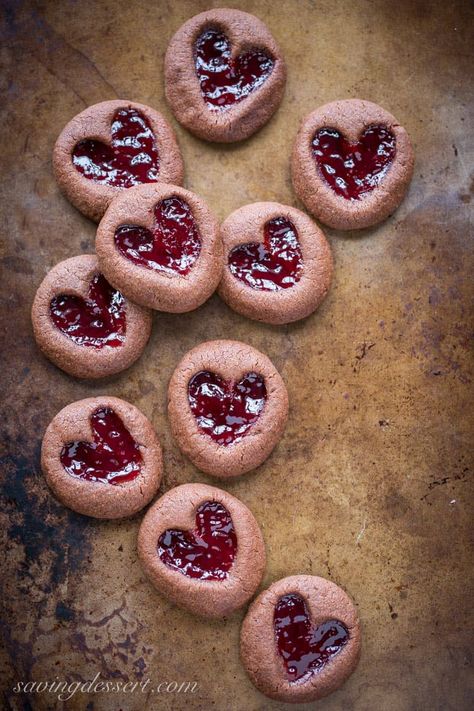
[114,197,201,275]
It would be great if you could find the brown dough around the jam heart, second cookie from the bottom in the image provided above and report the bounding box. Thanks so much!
[138,484,266,618]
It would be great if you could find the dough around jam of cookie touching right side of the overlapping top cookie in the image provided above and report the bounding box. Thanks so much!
[219,202,333,324]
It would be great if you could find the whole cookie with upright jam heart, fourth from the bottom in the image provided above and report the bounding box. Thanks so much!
[168,341,288,478]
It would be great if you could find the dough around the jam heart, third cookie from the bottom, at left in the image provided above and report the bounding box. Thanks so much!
[41,395,163,519]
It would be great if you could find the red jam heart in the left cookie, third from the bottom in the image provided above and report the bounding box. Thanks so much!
[61,407,143,484]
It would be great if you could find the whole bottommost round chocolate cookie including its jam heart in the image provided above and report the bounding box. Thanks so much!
[240,575,361,703]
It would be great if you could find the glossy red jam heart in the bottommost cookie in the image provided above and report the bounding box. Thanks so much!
[273,593,349,682]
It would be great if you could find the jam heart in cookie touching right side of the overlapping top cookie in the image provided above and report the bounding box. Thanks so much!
[229,217,303,291]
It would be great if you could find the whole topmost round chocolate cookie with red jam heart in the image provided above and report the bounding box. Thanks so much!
[165,9,286,143]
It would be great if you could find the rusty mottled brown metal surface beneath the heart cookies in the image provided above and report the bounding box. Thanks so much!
[0,0,474,711]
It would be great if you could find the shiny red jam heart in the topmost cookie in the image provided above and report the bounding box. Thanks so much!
[195,29,274,111]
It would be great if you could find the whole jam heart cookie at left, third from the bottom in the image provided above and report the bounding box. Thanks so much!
[41,395,163,519]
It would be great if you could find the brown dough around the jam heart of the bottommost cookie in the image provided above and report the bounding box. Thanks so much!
[240,575,361,703]
